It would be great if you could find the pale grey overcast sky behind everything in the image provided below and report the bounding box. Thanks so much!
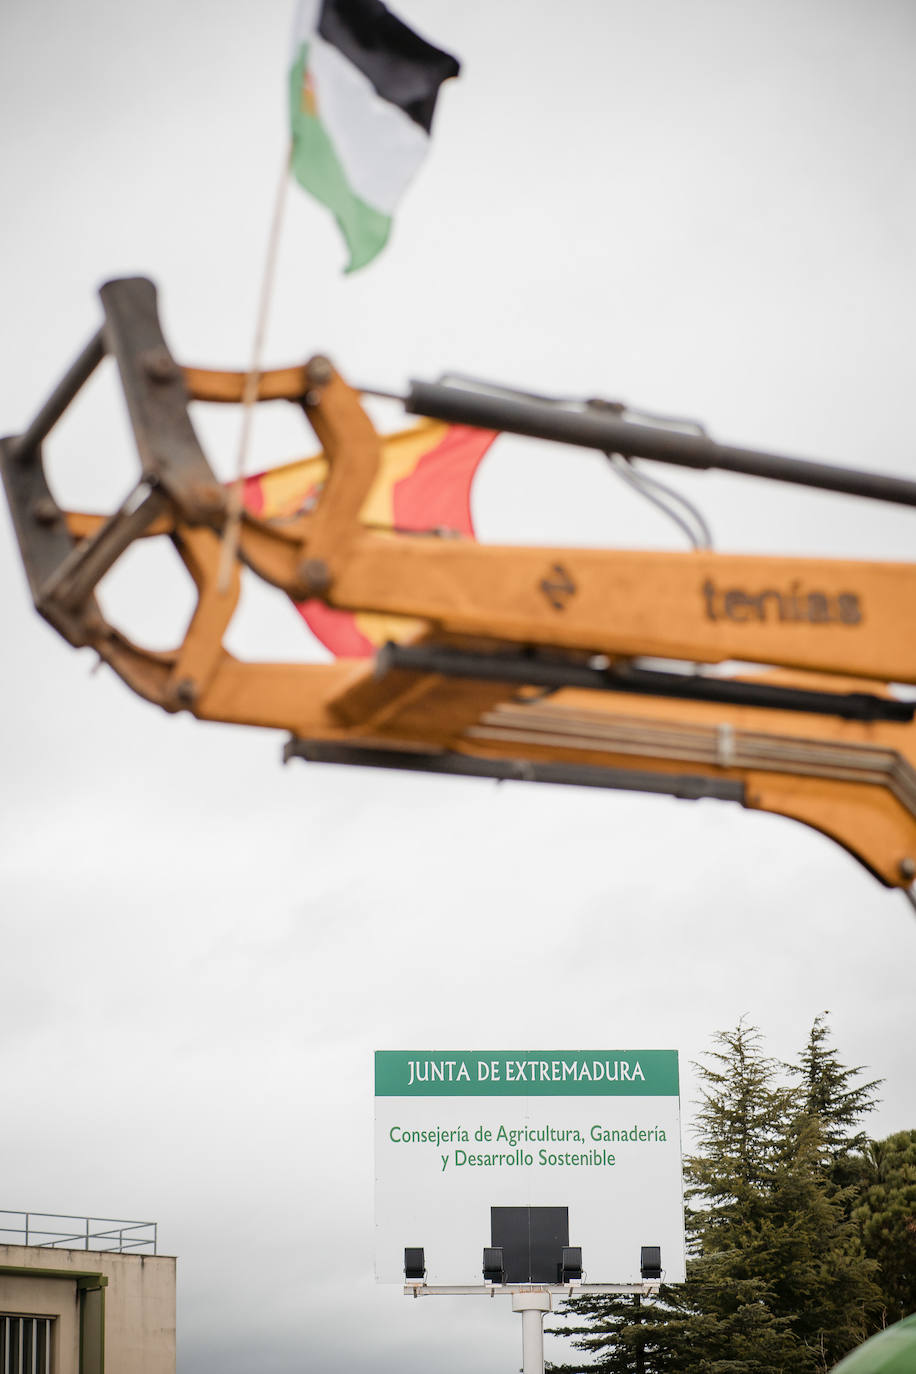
[0,0,916,1374]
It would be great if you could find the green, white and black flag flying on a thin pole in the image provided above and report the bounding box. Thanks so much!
[290,0,459,272]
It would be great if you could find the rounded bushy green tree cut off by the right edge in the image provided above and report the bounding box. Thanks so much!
[853,1131,916,1327]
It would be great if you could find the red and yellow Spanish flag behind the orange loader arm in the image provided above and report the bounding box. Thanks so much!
[243,420,496,658]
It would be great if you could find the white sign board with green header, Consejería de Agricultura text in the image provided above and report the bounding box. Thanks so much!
[375,1050,685,1283]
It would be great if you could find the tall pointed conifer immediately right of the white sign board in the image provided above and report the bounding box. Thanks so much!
[672,1024,878,1371]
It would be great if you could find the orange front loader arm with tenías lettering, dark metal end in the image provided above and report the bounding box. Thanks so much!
[0,279,916,889]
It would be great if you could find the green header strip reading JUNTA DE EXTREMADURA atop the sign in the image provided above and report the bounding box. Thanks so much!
[375,1050,678,1098]
